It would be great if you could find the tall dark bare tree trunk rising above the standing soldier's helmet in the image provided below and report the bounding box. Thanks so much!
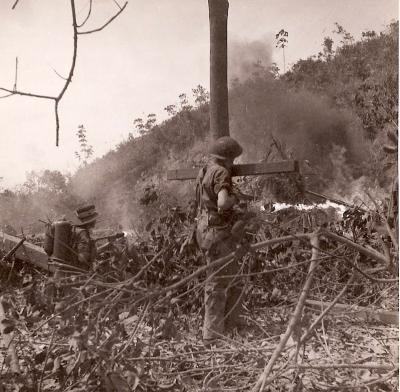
[208,0,229,139]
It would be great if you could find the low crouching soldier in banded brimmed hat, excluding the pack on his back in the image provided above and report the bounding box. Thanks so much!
[72,205,98,268]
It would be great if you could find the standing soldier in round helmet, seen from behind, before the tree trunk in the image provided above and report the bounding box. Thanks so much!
[196,137,247,345]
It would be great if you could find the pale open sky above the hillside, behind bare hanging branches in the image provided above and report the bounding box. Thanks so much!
[0,0,398,189]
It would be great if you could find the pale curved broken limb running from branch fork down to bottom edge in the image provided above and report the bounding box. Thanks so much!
[252,233,319,392]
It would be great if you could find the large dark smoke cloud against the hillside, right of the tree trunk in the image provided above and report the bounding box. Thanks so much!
[230,76,367,194]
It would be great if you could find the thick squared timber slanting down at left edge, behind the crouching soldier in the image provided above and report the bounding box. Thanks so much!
[0,231,54,272]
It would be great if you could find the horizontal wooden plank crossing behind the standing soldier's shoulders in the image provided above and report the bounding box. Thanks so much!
[167,160,299,180]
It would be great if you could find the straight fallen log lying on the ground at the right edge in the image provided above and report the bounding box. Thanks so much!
[306,299,399,325]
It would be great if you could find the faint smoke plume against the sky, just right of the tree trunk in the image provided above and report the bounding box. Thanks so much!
[228,37,272,84]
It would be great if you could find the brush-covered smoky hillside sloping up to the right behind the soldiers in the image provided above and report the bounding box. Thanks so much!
[0,23,398,233]
